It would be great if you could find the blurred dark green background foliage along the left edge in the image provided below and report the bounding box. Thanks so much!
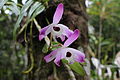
[0,13,25,80]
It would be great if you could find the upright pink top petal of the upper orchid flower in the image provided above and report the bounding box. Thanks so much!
[53,3,63,24]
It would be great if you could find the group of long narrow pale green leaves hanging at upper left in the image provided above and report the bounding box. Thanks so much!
[13,0,45,39]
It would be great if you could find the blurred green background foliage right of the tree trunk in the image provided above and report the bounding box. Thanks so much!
[87,0,120,80]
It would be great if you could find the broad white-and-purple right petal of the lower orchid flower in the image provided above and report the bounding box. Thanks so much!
[69,48,85,63]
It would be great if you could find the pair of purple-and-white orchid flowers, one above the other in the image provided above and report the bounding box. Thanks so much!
[39,3,85,66]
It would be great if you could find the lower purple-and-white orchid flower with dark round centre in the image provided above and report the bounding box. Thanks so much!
[44,29,85,66]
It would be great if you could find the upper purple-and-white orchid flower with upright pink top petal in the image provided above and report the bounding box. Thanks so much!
[39,3,73,41]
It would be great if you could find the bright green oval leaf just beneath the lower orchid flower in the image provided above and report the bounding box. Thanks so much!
[68,62,86,76]
